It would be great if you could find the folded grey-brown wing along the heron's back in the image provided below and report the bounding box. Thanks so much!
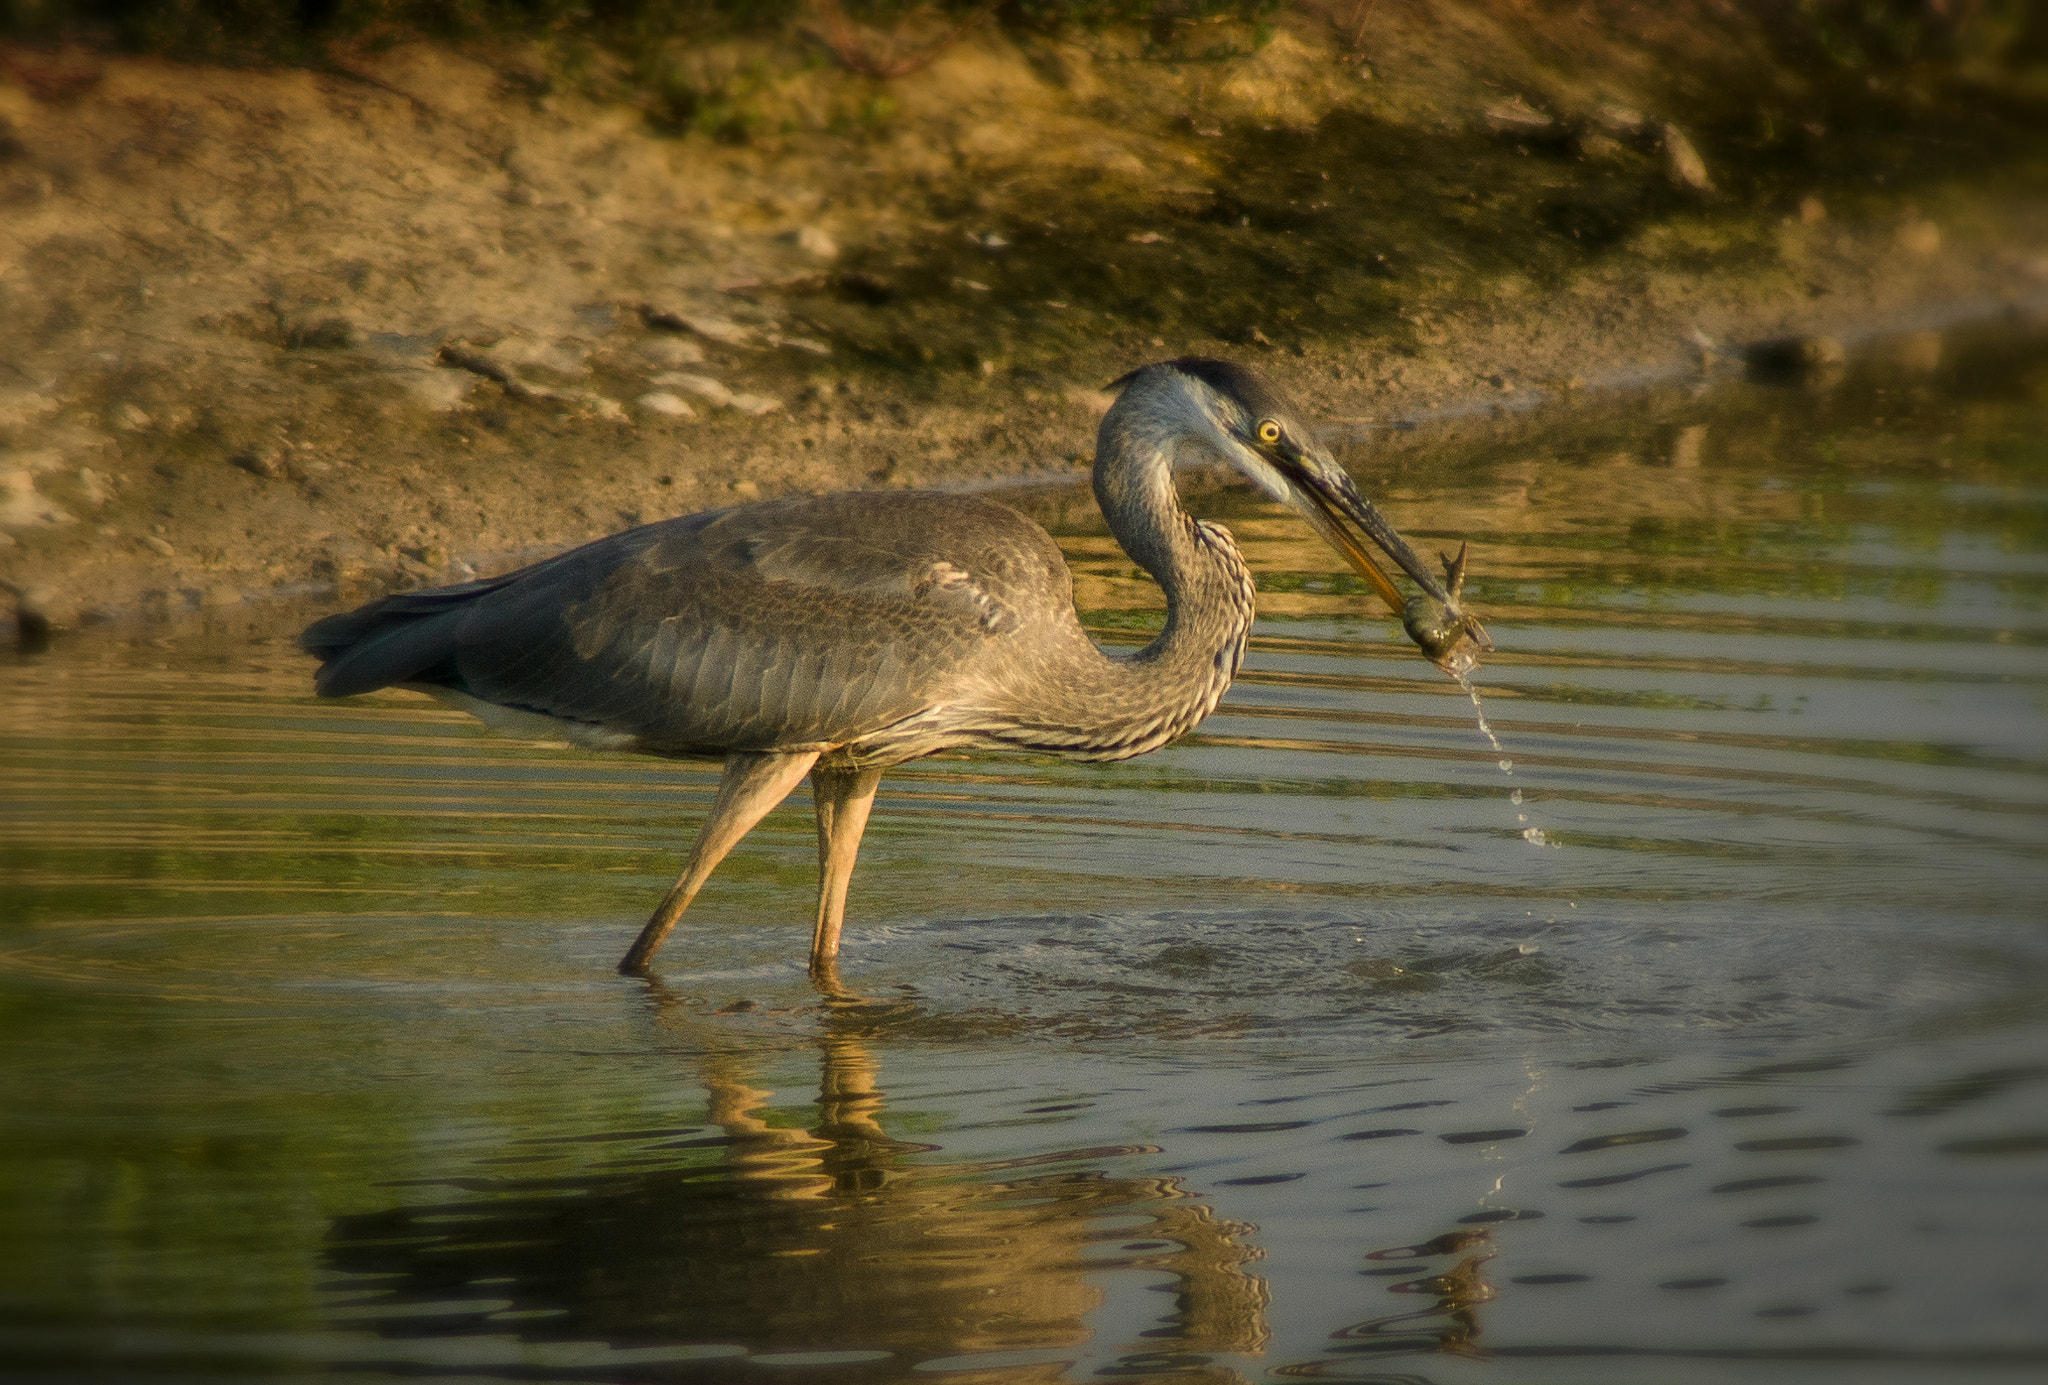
[309,496,1071,750]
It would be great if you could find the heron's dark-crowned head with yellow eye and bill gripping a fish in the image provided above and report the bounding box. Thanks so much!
[1112,356,1493,672]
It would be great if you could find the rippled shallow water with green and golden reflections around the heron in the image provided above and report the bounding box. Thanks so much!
[0,321,2048,1385]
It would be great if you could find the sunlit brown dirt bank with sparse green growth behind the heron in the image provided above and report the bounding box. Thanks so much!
[0,0,2048,627]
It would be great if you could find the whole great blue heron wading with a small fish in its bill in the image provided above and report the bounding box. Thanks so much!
[299,356,1489,977]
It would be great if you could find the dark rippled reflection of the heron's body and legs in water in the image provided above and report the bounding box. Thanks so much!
[328,1006,1268,1379]
